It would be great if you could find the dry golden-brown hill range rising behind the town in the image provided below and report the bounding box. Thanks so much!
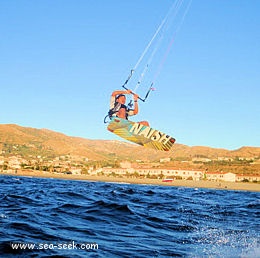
[0,124,260,162]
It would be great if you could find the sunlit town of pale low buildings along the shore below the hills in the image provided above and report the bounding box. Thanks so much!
[0,155,260,183]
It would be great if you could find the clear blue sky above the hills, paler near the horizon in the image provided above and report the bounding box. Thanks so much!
[0,0,260,149]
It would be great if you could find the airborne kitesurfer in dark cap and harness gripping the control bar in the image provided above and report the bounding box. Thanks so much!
[109,90,149,126]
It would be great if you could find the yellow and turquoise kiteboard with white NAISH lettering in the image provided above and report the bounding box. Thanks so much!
[107,117,175,151]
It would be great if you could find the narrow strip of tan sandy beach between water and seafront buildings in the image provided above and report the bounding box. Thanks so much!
[0,171,260,192]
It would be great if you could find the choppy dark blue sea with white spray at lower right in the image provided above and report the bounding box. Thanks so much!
[0,175,260,258]
